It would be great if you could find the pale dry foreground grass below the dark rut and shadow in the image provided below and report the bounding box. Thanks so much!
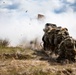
[0,59,76,75]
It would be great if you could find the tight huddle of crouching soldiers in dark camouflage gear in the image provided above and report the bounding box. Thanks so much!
[42,23,76,61]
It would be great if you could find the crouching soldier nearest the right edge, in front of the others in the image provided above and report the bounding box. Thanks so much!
[57,36,76,62]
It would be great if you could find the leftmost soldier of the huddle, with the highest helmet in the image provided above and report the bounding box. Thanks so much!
[42,23,57,50]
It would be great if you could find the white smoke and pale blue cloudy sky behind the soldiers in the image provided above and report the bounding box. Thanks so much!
[0,0,76,45]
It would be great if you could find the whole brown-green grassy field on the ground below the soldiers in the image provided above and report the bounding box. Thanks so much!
[0,47,76,75]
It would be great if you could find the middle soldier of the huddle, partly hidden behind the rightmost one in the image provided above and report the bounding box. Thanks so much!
[54,27,69,54]
